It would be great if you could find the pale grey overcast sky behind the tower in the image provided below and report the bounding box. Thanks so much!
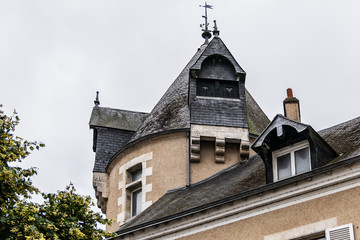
[0,0,360,209]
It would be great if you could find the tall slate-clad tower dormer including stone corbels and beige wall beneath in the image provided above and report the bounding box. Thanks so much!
[189,29,249,182]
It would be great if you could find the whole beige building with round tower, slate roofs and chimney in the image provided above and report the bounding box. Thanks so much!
[90,25,360,240]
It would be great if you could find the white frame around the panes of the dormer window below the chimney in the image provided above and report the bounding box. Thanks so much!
[272,140,311,182]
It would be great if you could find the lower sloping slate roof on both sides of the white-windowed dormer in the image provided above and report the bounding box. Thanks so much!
[117,117,360,234]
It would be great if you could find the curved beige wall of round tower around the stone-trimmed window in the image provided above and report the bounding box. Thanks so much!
[106,133,187,231]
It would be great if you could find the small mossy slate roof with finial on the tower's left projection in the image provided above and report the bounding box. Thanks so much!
[89,107,148,131]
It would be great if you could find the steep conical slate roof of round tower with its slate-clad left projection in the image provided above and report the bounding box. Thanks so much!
[89,38,269,172]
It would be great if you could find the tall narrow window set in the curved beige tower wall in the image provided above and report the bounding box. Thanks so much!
[126,164,142,217]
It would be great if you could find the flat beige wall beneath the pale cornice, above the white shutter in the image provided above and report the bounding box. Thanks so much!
[181,187,360,240]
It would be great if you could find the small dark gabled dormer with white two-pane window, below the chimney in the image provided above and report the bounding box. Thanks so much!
[252,115,338,183]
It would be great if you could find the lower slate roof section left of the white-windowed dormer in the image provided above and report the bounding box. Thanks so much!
[119,155,265,233]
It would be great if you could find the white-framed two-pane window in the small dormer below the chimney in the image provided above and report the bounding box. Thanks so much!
[273,141,311,181]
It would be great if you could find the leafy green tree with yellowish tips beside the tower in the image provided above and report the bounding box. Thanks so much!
[0,105,113,240]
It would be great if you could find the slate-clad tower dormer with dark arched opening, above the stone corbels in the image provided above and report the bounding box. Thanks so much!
[189,37,248,128]
